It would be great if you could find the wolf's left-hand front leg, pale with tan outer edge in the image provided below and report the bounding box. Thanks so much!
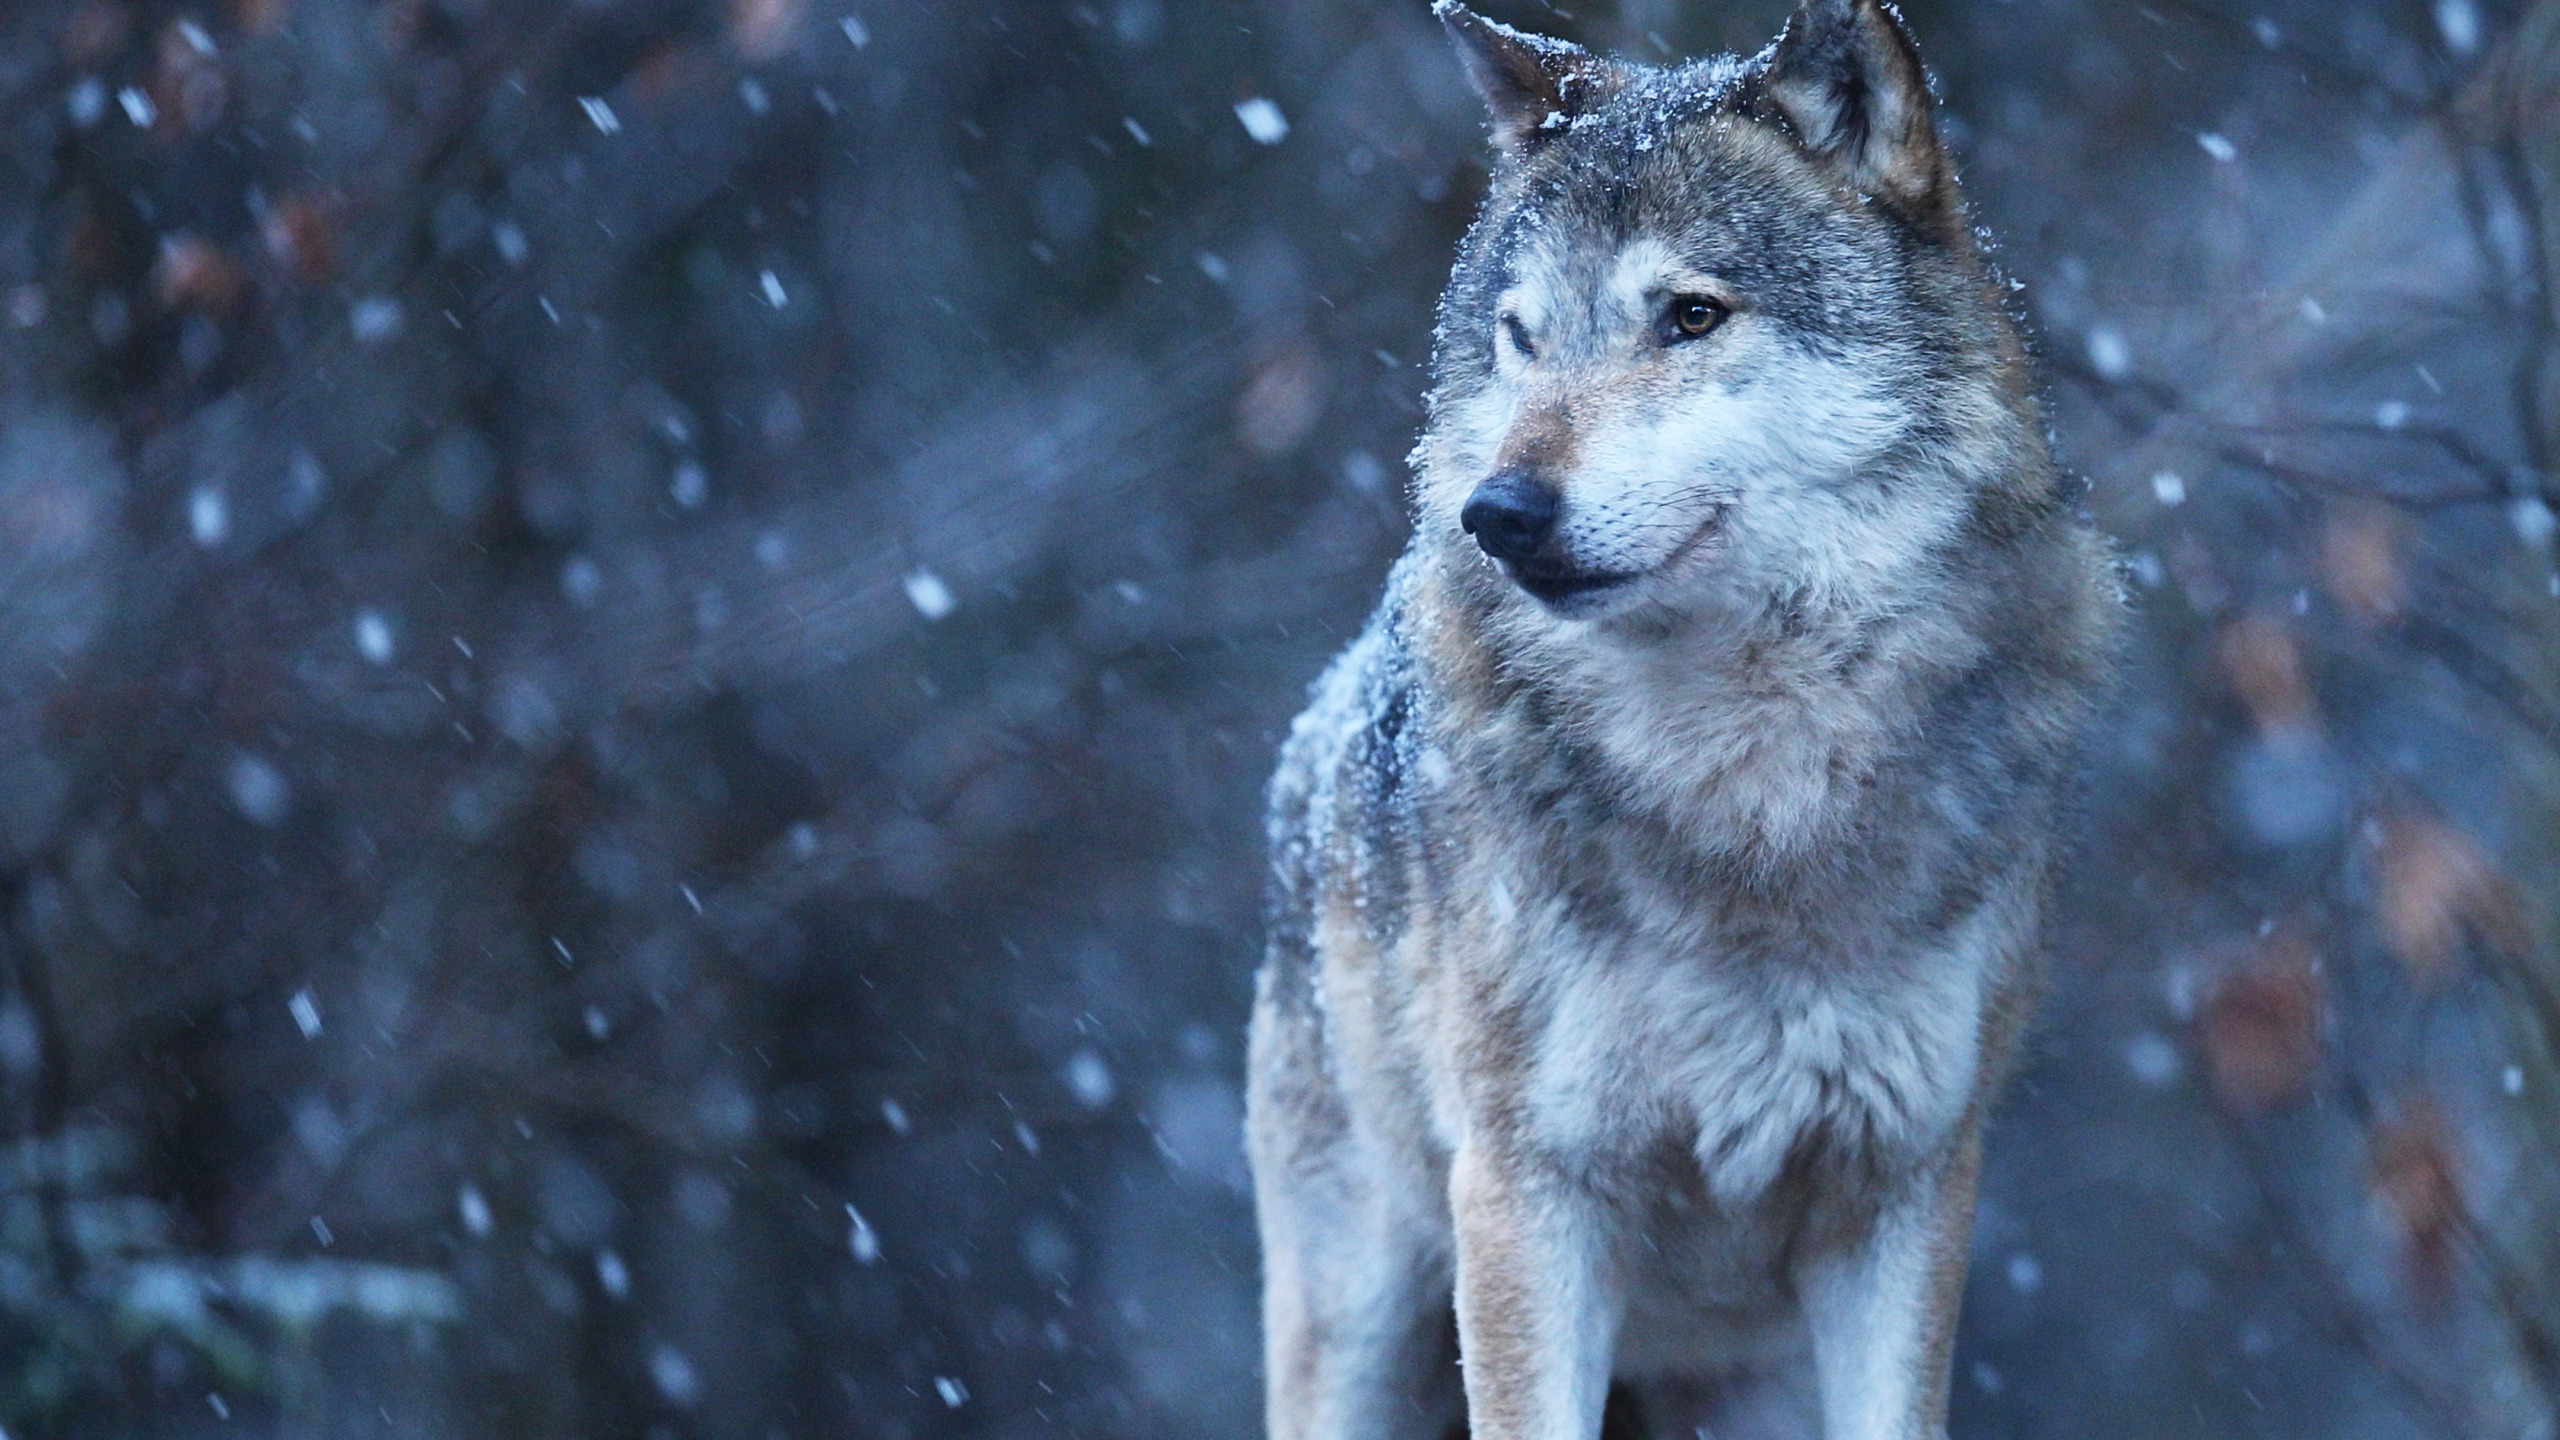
[1449,1143,1626,1440]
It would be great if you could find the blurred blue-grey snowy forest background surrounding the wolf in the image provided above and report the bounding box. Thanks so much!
[0,0,2560,1440]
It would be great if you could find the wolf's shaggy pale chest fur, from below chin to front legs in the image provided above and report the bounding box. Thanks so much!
[1413,599,2012,1204]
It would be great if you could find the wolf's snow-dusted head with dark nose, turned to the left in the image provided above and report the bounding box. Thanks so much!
[1416,0,2051,620]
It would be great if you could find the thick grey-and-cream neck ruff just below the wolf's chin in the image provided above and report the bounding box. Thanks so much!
[1413,543,1987,860]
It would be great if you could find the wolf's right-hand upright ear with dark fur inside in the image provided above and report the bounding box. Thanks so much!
[1766,0,1946,200]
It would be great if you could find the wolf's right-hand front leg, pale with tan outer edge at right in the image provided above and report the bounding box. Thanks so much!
[1797,1120,1981,1440]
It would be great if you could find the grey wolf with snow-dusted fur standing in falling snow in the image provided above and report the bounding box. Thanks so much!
[1247,0,2122,1440]
